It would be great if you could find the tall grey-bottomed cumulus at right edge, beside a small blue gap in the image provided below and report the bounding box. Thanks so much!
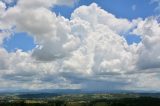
[133,17,160,69]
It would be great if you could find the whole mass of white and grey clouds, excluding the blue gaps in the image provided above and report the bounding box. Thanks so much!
[0,0,160,89]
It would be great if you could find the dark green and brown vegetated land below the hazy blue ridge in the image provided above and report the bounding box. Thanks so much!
[0,93,160,106]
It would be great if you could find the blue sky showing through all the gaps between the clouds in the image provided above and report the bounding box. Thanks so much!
[3,0,157,52]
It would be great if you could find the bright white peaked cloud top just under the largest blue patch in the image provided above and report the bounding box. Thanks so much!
[71,3,133,33]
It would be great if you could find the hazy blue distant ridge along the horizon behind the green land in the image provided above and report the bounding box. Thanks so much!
[0,89,160,98]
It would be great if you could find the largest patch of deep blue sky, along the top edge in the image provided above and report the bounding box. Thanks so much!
[53,0,157,19]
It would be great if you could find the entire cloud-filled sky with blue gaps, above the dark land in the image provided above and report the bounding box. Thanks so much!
[0,0,160,91]
